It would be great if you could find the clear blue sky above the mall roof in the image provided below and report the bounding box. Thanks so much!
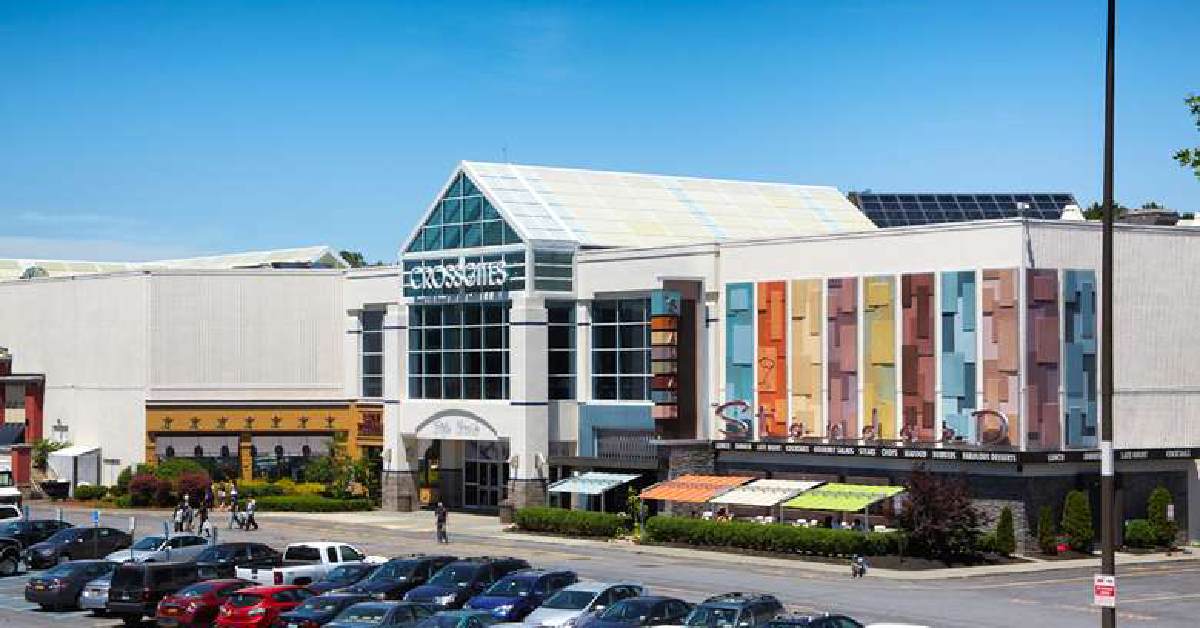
[0,0,1200,259]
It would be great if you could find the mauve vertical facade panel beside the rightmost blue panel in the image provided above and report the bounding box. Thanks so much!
[1025,269,1062,449]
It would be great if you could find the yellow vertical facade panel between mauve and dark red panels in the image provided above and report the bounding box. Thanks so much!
[862,277,896,439]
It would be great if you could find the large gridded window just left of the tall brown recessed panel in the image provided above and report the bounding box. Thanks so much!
[592,299,650,401]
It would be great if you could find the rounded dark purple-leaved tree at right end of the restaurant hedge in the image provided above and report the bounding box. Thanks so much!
[899,465,983,562]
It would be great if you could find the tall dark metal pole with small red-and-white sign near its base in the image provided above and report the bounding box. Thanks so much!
[1100,0,1117,628]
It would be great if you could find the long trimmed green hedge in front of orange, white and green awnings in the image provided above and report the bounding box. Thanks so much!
[646,516,904,556]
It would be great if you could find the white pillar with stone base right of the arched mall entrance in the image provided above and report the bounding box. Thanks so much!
[500,295,550,520]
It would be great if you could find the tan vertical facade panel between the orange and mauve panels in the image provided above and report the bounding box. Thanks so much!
[791,279,824,437]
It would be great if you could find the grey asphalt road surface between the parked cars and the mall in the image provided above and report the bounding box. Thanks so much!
[0,509,1200,628]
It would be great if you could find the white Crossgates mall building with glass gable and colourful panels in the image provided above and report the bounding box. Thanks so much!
[0,162,1200,538]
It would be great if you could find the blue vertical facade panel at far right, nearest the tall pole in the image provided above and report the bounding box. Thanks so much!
[1062,270,1099,448]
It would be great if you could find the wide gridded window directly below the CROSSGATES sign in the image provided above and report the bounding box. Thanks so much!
[408,301,509,399]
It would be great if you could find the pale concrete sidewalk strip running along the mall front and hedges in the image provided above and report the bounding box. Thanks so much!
[259,510,1200,581]
